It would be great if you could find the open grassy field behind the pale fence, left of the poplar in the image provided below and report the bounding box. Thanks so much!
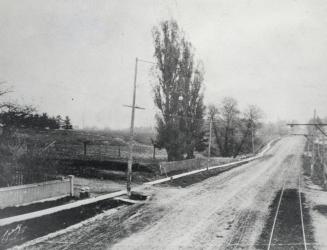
[0,129,166,186]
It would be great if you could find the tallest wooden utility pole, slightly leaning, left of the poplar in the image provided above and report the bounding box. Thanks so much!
[126,57,138,197]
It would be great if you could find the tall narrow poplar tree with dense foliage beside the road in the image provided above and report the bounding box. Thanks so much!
[153,20,205,161]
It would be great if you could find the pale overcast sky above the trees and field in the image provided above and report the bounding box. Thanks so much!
[0,0,327,128]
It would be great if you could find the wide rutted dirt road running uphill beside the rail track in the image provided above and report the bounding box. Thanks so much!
[21,137,305,249]
